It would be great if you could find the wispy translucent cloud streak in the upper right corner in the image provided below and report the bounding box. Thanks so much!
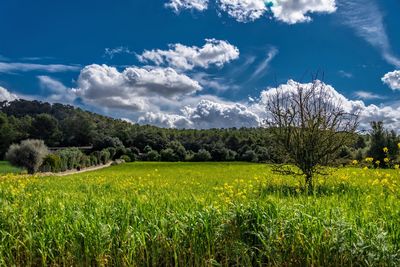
[339,0,400,67]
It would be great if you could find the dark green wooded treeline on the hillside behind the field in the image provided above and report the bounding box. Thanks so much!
[0,100,399,166]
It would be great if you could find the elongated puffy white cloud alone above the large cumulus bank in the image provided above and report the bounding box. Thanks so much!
[138,39,239,70]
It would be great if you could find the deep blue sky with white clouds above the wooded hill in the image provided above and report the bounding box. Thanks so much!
[0,0,400,130]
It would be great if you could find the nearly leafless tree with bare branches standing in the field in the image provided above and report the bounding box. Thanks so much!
[266,79,359,191]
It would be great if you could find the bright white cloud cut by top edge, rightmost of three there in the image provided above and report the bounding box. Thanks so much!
[271,0,336,24]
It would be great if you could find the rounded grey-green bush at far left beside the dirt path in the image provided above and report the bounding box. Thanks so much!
[6,139,49,174]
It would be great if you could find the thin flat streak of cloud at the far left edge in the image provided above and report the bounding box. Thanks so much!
[0,62,80,73]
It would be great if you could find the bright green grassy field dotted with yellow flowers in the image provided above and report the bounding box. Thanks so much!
[0,163,400,266]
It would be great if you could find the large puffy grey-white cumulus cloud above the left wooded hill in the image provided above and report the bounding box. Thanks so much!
[72,65,202,111]
